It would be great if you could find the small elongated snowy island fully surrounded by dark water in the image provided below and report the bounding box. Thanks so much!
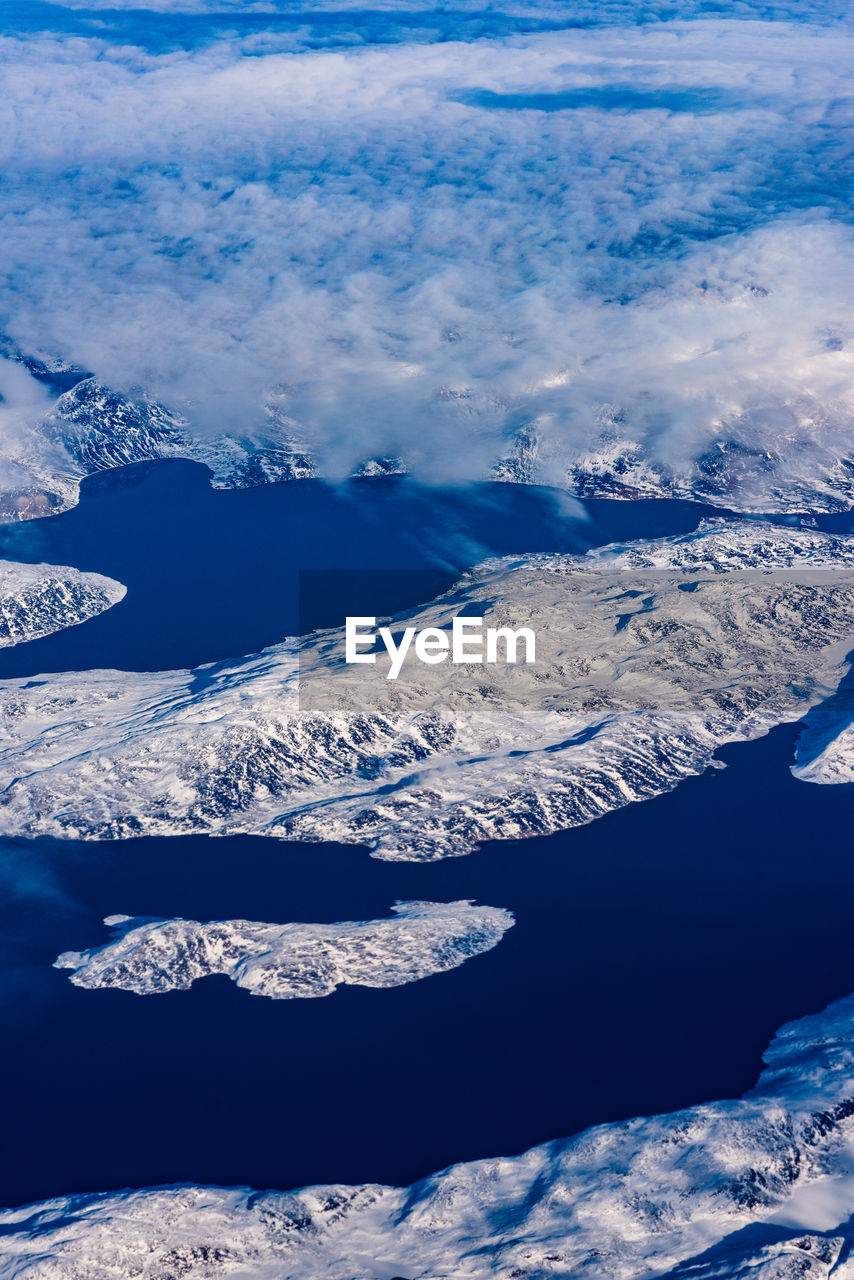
[55,900,513,1000]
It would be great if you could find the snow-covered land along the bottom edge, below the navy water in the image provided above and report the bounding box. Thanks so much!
[8,997,854,1280]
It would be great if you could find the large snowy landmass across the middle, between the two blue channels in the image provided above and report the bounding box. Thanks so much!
[0,521,854,859]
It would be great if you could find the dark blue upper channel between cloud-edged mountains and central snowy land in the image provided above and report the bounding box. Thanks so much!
[0,462,737,678]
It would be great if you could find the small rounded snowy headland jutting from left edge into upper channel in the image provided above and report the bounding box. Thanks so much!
[0,561,125,646]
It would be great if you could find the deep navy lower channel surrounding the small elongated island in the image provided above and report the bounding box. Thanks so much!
[0,726,854,1203]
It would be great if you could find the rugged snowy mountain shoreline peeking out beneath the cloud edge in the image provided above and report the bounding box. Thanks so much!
[0,375,854,520]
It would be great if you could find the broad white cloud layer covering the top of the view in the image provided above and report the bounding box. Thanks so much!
[0,5,854,481]
